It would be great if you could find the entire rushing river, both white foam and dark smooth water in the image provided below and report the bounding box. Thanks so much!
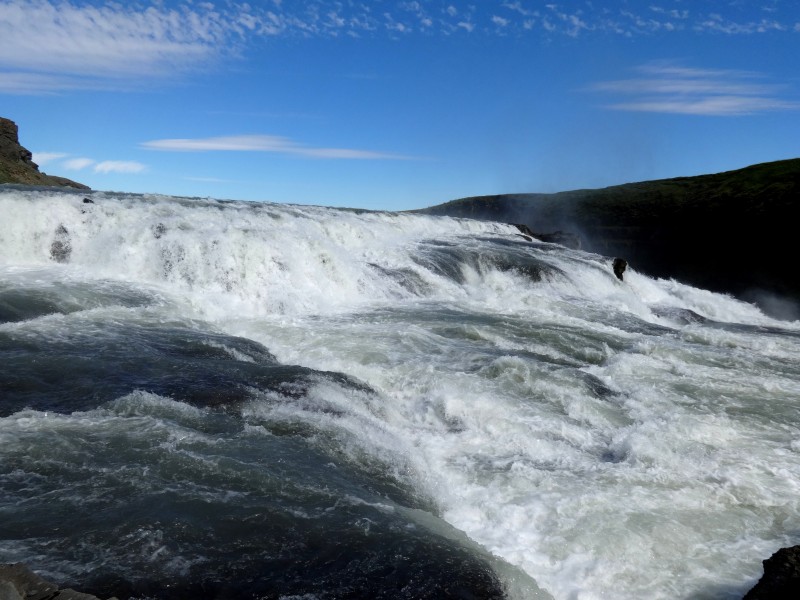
[0,186,800,600]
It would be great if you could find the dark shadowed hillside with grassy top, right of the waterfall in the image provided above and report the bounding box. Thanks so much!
[420,159,800,310]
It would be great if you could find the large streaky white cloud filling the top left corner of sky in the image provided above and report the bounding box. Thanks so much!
[0,0,244,93]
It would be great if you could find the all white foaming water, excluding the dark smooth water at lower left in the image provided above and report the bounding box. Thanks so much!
[0,185,800,599]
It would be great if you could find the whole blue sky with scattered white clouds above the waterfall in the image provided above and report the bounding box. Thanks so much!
[0,0,800,210]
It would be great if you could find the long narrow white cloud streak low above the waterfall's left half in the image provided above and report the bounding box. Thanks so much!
[141,135,412,160]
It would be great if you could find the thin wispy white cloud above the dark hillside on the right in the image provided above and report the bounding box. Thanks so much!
[591,63,800,117]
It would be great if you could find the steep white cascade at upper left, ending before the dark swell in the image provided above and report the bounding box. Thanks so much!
[0,190,524,315]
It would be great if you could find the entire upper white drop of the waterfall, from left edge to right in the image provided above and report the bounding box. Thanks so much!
[0,189,788,327]
